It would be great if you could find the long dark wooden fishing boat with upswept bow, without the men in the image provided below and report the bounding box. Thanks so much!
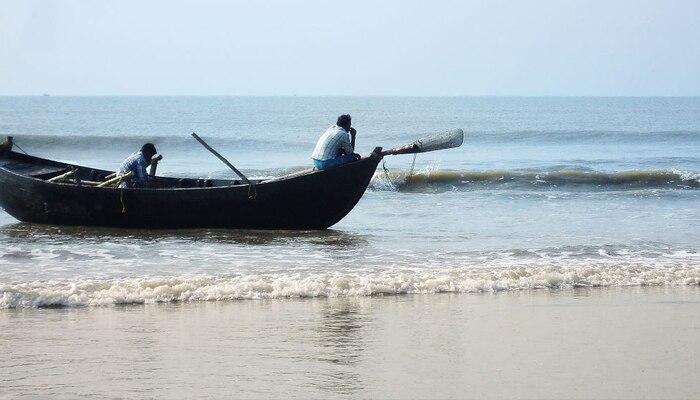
[0,130,461,229]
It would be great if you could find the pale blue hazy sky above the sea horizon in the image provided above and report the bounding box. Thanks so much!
[0,0,700,96]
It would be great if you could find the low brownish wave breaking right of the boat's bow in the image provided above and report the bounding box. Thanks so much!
[370,168,700,191]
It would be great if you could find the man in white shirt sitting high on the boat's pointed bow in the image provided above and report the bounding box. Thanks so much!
[311,114,360,169]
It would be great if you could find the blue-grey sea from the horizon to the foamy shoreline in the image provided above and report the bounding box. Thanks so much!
[0,97,700,307]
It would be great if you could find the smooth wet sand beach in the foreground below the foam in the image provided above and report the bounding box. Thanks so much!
[0,286,700,399]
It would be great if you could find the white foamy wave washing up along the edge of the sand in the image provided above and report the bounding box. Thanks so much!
[0,264,700,308]
